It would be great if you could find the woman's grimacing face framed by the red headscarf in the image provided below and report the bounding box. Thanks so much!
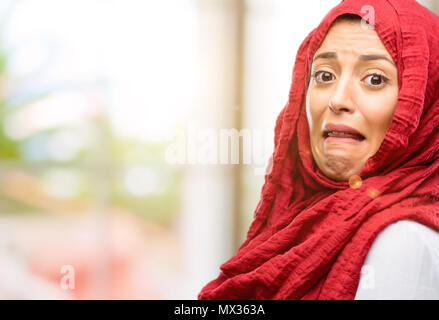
[306,21,399,181]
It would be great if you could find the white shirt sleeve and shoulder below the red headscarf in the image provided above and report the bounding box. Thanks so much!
[355,220,439,300]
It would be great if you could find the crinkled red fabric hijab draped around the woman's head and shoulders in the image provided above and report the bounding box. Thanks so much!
[198,0,439,299]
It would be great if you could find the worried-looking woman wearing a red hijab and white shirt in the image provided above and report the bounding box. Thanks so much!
[198,0,439,299]
